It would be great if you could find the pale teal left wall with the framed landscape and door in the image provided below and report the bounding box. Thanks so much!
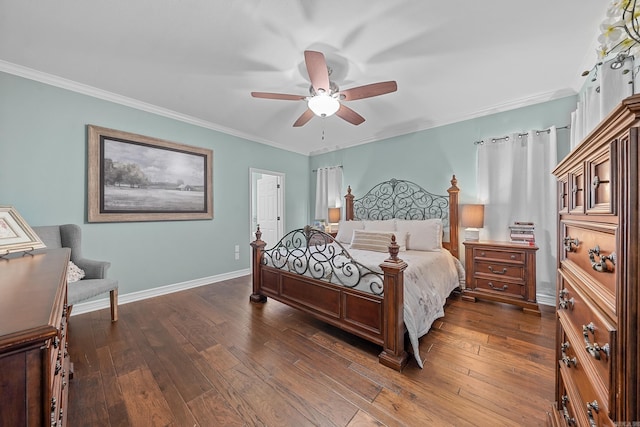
[0,73,310,295]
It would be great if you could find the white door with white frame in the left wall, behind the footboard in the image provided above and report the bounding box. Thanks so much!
[249,168,284,247]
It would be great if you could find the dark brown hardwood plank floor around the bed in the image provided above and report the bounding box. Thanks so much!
[67,276,555,427]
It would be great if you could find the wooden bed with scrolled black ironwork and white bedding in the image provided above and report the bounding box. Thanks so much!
[250,175,464,371]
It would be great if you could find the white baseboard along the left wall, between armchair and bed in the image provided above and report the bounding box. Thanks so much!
[71,268,251,316]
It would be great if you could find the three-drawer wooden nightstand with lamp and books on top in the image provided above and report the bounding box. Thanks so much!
[462,241,540,315]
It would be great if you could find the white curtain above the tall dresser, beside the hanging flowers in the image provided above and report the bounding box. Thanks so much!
[571,58,640,148]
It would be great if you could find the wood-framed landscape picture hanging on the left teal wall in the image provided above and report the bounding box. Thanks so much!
[87,125,213,222]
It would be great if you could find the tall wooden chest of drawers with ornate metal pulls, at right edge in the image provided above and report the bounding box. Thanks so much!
[549,95,640,426]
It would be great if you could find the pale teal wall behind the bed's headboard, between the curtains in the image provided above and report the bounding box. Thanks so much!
[309,96,576,220]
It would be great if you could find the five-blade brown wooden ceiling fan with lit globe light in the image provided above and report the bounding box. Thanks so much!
[251,50,398,127]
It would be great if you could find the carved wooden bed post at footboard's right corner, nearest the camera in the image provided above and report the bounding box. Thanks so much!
[378,235,409,371]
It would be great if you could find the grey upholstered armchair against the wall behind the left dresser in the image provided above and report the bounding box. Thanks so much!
[33,224,118,322]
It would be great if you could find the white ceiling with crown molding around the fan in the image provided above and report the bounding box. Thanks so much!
[0,0,608,154]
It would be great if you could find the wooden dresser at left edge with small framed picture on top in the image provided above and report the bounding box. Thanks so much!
[0,249,70,427]
